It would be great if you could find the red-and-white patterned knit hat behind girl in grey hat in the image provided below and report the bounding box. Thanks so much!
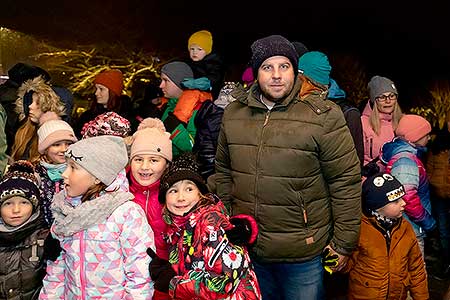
[81,111,131,139]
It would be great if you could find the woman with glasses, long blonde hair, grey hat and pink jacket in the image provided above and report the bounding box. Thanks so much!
[361,76,402,165]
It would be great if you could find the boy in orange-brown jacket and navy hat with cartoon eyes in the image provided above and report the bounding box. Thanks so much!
[344,173,429,299]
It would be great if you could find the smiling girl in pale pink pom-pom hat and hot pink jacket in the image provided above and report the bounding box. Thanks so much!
[127,118,172,300]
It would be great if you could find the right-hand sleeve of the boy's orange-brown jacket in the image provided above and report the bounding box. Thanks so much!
[403,220,430,299]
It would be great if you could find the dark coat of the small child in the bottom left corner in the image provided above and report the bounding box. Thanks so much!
[0,213,49,300]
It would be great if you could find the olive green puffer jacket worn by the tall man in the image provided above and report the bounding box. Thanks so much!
[215,79,361,262]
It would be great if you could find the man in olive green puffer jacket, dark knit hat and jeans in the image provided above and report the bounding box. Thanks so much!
[215,35,361,300]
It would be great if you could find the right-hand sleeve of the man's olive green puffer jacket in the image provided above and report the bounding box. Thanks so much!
[317,107,361,255]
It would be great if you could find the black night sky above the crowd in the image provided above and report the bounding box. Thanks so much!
[0,0,450,105]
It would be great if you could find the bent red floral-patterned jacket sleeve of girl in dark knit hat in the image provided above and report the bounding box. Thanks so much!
[169,213,253,299]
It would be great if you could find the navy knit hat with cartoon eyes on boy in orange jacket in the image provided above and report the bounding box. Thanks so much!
[362,173,405,216]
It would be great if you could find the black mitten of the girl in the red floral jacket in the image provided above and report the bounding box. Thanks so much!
[147,248,177,293]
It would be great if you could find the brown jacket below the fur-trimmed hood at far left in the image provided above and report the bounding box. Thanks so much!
[11,119,39,164]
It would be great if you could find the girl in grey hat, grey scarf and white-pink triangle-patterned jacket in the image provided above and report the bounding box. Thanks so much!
[39,135,155,300]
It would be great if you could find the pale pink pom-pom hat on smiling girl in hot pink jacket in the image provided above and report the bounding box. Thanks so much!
[130,118,172,161]
